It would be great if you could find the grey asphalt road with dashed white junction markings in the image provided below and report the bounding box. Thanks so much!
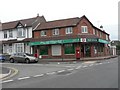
[2,58,118,88]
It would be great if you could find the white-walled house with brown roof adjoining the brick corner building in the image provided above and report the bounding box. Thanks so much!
[0,15,46,54]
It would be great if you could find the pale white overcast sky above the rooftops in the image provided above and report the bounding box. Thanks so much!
[0,0,119,40]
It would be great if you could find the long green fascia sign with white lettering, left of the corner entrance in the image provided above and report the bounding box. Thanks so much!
[29,38,80,46]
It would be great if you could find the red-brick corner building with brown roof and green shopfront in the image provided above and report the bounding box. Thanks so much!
[29,15,110,59]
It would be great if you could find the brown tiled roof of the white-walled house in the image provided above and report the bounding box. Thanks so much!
[2,16,46,30]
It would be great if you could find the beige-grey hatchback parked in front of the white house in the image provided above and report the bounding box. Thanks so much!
[9,53,38,63]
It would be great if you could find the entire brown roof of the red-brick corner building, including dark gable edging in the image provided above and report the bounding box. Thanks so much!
[34,15,109,35]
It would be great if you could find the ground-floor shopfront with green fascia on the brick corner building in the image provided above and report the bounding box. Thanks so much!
[29,38,109,59]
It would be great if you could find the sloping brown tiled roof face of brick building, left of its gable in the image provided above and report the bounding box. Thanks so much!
[36,17,80,30]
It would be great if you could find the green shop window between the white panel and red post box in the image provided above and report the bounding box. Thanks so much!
[64,44,75,54]
